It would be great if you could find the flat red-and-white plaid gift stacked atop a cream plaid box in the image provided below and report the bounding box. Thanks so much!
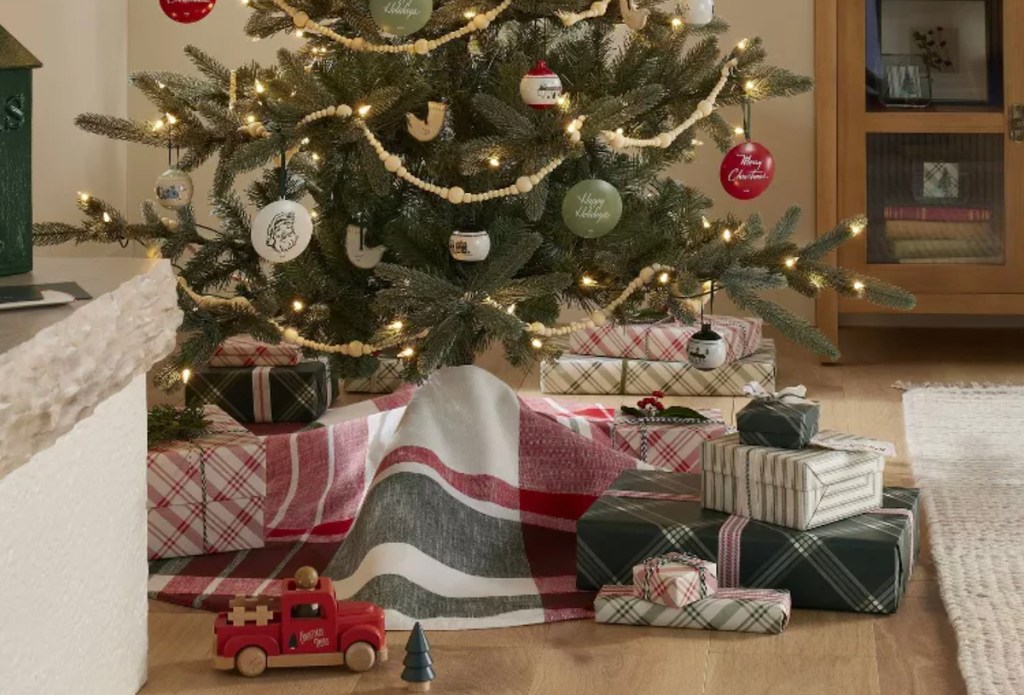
[569,316,764,362]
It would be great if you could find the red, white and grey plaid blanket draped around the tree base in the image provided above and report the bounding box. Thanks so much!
[150,367,638,629]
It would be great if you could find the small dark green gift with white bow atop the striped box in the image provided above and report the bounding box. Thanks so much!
[736,382,821,449]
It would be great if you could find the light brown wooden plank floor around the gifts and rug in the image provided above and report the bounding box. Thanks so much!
[142,329,1024,695]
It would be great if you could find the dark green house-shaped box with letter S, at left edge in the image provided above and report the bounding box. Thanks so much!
[0,27,42,276]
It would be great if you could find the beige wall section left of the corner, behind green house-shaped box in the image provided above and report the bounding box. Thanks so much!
[0,0,128,255]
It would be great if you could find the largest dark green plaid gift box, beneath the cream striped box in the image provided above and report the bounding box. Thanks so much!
[577,471,920,613]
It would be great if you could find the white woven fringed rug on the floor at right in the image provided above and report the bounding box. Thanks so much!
[903,386,1024,695]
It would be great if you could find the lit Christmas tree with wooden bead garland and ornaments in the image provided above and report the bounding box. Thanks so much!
[35,0,913,385]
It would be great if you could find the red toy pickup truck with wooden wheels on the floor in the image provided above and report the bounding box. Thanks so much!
[213,567,387,678]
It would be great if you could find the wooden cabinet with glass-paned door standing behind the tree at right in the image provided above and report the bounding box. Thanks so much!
[816,0,1024,350]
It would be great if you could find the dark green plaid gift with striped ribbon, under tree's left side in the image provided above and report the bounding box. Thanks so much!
[185,360,338,423]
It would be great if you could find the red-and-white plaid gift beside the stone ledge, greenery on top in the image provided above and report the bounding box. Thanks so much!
[146,406,266,560]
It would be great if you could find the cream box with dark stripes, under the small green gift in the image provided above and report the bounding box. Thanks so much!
[700,434,886,530]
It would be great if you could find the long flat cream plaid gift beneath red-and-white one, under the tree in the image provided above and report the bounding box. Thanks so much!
[541,340,775,396]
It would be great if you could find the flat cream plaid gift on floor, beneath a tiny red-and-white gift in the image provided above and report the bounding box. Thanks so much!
[594,585,792,635]
